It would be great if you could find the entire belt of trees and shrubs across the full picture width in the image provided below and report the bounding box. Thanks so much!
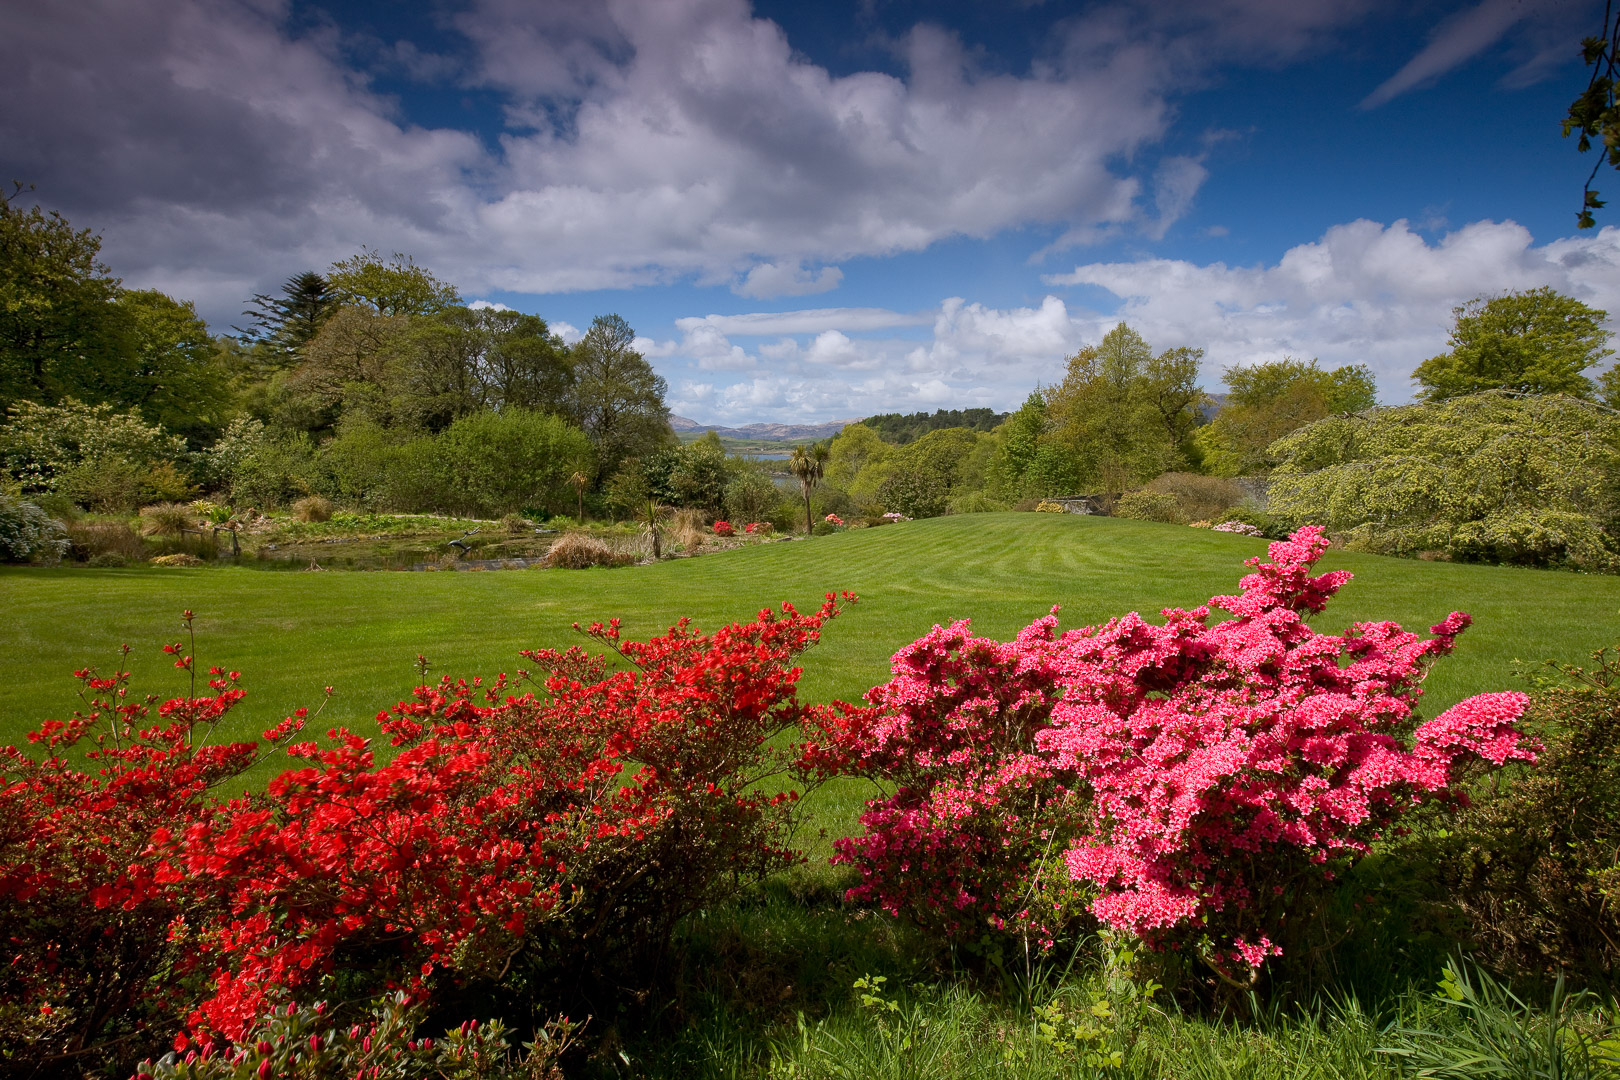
[0,184,1620,568]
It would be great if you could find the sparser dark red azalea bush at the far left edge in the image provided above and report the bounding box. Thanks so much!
[0,625,314,1072]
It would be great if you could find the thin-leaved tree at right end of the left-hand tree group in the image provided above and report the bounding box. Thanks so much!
[570,314,676,474]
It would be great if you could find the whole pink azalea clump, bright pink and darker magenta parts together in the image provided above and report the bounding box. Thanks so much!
[813,526,1536,984]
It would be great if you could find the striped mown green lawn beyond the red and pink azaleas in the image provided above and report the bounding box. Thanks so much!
[0,513,1620,757]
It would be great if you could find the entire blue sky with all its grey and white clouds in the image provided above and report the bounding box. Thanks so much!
[0,0,1620,424]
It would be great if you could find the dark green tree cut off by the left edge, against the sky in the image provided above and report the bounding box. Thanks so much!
[0,188,128,408]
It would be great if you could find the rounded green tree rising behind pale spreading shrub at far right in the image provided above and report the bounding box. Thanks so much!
[1413,287,1612,402]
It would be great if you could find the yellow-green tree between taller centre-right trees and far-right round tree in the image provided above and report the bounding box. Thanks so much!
[1194,356,1377,476]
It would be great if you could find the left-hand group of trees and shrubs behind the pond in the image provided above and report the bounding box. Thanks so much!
[0,193,677,513]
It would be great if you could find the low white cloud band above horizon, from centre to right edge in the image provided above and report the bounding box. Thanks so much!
[664,220,1620,423]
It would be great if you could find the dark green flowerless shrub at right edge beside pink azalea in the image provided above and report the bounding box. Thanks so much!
[1426,649,1620,978]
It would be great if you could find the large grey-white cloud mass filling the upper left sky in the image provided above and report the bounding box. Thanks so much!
[0,0,1362,322]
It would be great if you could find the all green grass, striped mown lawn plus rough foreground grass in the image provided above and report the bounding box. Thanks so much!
[0,513,1620,1080]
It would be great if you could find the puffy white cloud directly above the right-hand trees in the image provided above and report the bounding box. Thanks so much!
[1045,220,1620,402]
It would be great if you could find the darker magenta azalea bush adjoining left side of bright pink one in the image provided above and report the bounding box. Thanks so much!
[807,615,1072,939]
